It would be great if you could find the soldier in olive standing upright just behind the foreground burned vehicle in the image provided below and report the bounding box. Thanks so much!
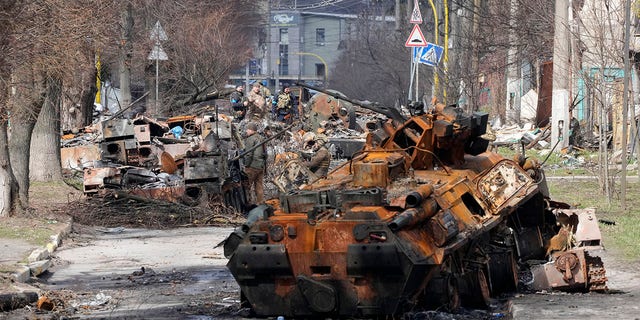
[242,122,266,204]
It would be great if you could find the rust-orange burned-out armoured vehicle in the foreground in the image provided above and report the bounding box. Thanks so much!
[225,88,606,318]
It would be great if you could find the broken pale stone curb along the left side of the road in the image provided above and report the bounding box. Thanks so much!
[0,219,73,311]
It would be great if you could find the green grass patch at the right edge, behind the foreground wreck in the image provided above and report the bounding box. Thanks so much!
[548,179,640,260]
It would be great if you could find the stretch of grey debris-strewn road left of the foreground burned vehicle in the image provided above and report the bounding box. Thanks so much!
[14,227,248,319]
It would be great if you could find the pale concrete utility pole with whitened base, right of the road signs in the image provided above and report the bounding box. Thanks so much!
[551,0,571,152]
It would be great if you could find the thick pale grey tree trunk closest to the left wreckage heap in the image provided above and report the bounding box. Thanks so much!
[29,77,62,181]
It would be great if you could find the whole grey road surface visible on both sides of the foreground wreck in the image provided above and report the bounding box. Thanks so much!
[5,226,640,320]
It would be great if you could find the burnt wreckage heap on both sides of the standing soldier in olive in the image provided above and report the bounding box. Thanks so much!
[61,91,374,219]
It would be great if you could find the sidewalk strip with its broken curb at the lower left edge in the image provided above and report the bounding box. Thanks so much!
[0,217,72,312]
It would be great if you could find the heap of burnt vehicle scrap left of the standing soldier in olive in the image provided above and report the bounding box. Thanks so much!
[62,105,246,211]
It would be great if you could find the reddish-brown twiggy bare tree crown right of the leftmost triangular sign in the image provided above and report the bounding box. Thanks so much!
[163,1,259,112]
